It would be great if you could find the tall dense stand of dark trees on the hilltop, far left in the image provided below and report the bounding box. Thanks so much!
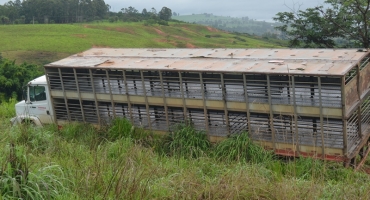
[0,0,110,24]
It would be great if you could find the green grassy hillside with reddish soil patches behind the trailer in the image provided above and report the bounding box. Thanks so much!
[0,23,281,64]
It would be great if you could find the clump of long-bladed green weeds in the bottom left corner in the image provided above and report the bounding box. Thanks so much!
[0,144,70,199]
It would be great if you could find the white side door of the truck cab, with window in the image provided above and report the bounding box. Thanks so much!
[28,85,53,124]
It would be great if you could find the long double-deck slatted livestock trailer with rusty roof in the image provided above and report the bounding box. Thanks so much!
[45,48,370,162]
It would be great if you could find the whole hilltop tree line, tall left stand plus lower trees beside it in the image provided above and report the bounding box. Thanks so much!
[0,0,174,24]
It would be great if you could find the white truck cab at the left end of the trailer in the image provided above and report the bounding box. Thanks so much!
[10,75,54,126]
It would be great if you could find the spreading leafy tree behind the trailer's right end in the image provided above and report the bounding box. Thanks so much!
[274,0,370,48]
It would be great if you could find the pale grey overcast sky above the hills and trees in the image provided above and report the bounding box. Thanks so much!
[0,0,324,21]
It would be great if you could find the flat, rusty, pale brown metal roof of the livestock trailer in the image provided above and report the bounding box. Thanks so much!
[46,48,368,76]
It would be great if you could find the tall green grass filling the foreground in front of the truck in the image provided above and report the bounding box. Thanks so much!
[0,99,370,199]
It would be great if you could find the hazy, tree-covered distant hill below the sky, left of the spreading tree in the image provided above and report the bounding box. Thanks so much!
[172,13,279,36]
